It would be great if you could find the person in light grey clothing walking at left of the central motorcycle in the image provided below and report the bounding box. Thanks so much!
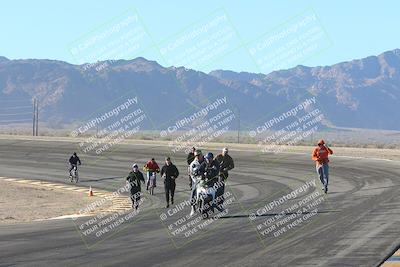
[189,149,206,216]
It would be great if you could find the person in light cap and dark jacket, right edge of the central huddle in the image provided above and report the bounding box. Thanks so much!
[215,147,235,211]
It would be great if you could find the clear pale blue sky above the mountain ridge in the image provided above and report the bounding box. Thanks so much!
[0,0,400,72]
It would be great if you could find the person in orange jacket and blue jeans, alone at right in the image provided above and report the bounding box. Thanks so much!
[312,139,333,194]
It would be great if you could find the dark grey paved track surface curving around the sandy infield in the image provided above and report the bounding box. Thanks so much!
[0,140,400,266]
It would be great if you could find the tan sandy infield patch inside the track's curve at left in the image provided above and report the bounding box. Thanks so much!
[0,179,103,224]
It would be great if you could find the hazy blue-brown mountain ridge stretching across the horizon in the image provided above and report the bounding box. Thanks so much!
[0,49,400,130]
